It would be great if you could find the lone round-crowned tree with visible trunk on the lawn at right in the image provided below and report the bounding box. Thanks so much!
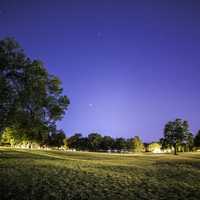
[162,119,190,155]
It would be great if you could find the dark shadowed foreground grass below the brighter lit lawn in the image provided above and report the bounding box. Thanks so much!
[0,158,200,200]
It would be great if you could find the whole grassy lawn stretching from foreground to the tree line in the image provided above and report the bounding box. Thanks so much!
[0,148,200,200]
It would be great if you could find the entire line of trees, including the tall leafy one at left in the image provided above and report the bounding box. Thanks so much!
[0,38,200,154]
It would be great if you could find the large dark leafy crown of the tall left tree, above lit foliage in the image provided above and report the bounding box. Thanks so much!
[0,38,69,141]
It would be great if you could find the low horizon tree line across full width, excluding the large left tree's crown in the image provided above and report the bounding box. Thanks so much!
[0,119,200,154]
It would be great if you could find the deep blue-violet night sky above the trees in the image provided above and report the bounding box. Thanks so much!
[0,0,200,141]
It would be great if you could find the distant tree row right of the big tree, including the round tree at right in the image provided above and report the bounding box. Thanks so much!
[67,126,200,154]
